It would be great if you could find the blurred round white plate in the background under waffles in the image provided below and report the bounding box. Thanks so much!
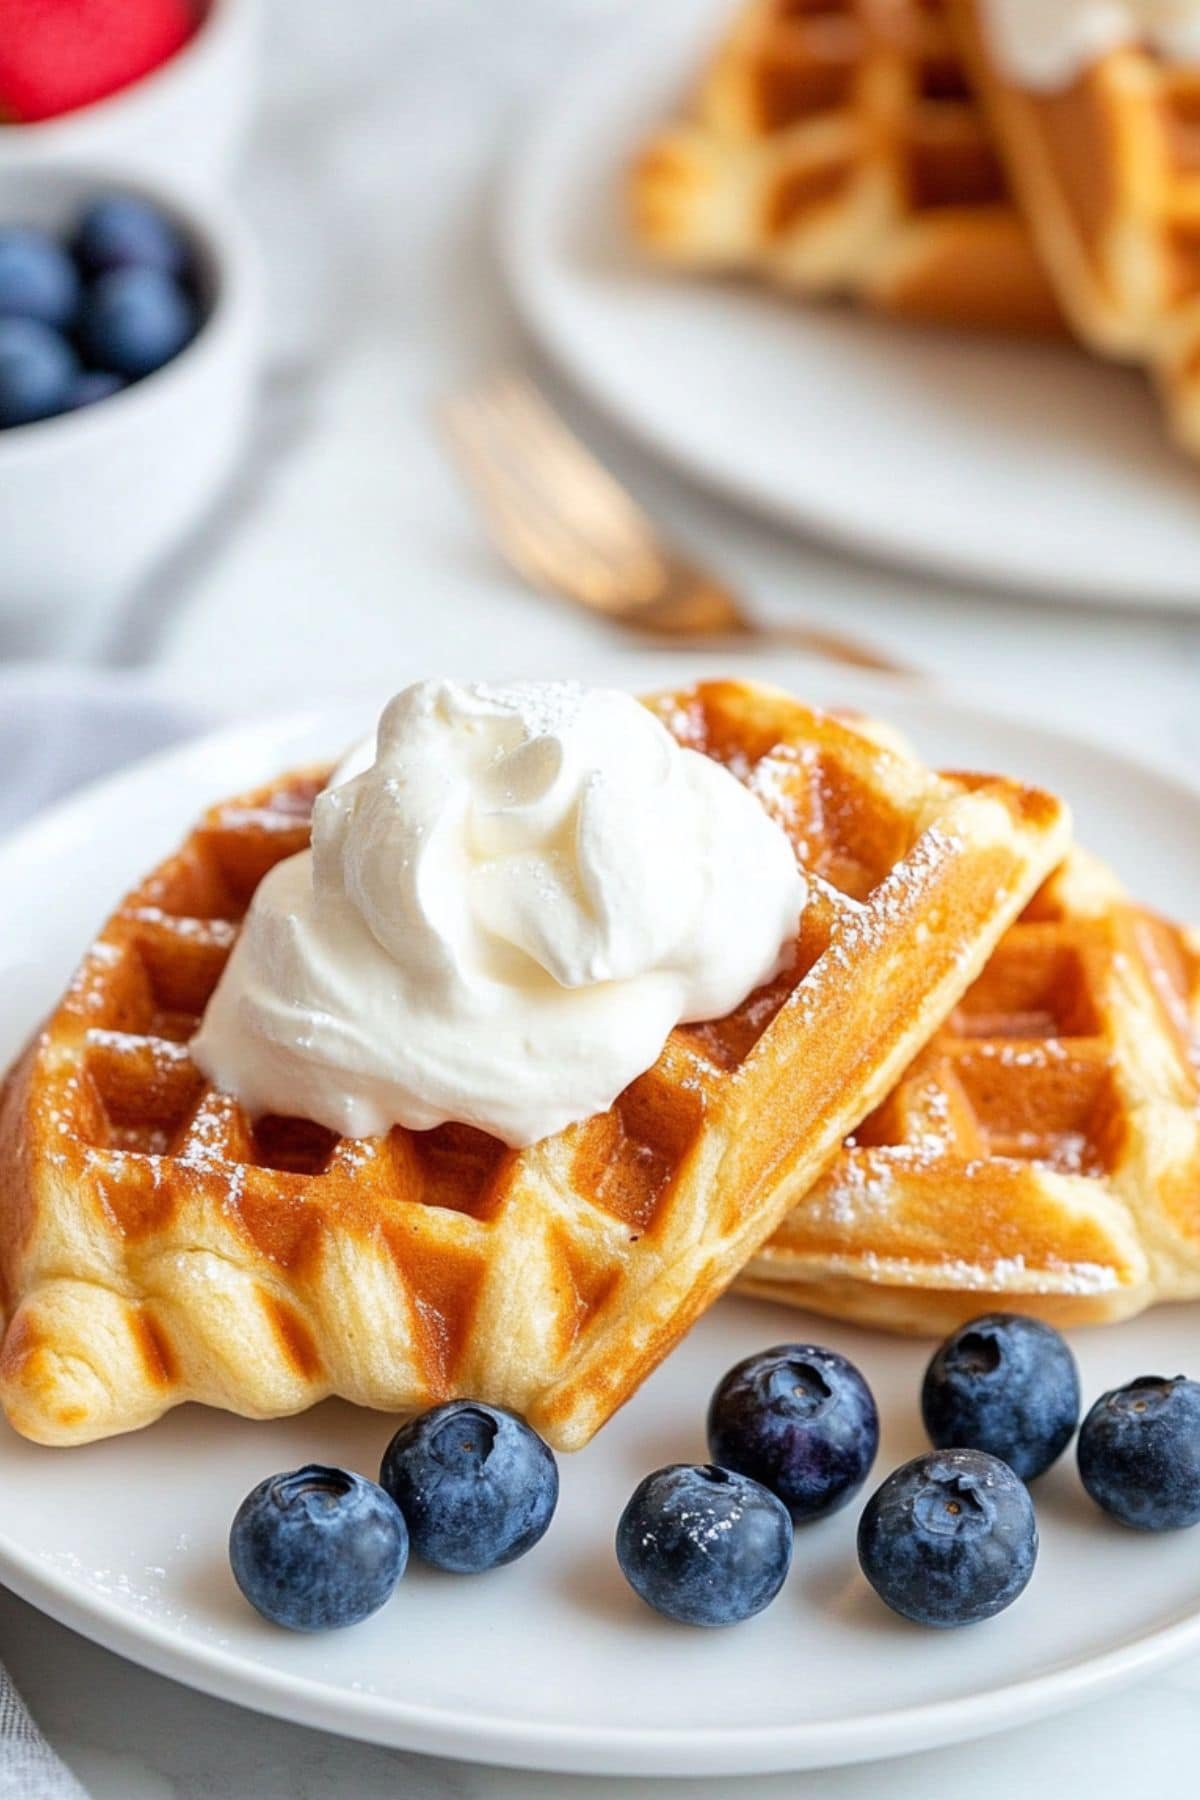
[500,0,1200,607]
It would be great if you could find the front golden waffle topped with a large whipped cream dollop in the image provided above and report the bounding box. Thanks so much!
[0,682,1067,1449]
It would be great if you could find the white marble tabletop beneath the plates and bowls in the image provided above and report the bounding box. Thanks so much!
[0,0,1200,1800]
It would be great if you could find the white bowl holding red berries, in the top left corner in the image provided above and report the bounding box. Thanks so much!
[0,0,257,189]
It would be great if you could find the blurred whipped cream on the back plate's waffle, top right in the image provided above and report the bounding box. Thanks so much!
[984,0,1200,90]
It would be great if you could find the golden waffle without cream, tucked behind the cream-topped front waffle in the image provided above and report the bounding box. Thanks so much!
[743,851,1200,1332]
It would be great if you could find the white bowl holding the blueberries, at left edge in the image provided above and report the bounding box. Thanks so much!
[0,169,261,623]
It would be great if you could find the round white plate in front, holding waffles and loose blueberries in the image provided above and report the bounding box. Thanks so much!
[0,655,1200,1775]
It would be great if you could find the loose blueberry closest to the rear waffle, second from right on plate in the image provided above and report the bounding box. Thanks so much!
[921,1312,1079,1481]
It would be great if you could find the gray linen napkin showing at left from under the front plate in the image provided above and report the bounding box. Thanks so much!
[0,664,200,1800]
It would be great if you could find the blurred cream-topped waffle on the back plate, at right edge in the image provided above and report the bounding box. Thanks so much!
[946,0,1200,452]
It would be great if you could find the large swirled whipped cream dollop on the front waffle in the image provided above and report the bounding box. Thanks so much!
[191,680,806,1145]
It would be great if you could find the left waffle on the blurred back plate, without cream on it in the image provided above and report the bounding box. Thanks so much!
[630,0,1061,331]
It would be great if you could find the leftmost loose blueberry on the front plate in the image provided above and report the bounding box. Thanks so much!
[228,1463,408,1631]
